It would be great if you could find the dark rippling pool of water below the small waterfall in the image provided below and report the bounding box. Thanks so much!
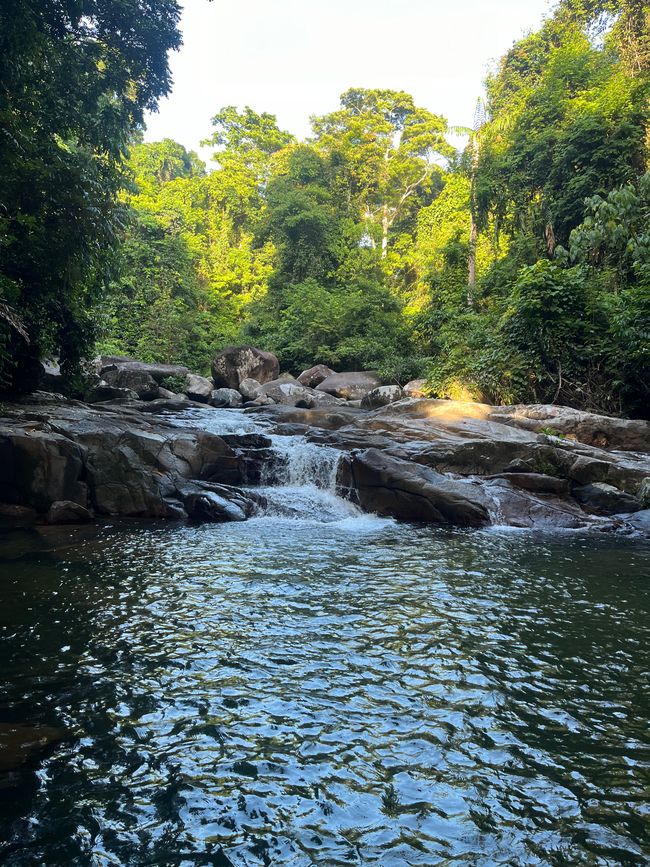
[0,516,650,867]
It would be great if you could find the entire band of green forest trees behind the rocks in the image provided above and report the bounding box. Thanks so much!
[0,0,650,413]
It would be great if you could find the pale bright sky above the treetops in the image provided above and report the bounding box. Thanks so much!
[145,0,552,159]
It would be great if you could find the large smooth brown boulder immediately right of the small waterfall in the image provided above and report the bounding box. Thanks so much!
[340,449,490,527]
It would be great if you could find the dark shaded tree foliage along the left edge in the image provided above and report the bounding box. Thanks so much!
[0,0,180,387]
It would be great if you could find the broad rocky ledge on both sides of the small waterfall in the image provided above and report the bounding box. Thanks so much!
[0,380,650,532]
